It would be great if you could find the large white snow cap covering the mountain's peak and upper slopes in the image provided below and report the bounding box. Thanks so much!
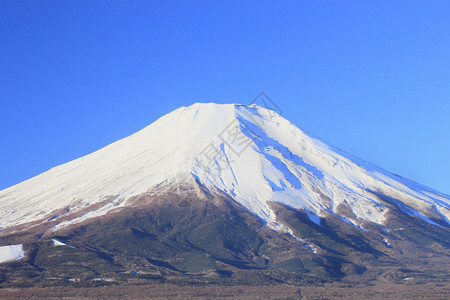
[0,103,450,229]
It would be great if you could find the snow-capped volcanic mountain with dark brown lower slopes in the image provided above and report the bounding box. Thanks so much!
[0,103,450,287]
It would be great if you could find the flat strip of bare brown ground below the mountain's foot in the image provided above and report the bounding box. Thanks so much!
[0,283,450,299]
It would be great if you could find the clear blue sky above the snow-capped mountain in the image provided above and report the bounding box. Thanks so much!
[0,0,450,194]
